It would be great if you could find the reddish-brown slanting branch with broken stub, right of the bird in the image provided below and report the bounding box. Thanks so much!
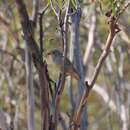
[70,11,119,130]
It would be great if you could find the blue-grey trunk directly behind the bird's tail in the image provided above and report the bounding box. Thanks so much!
[70,10,88,130]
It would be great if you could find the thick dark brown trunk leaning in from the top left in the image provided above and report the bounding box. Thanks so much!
[15,0,50,130]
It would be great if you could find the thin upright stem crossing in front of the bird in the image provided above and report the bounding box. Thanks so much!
[51,0,70,129]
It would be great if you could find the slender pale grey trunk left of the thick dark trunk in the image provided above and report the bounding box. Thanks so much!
[25,44,35,130]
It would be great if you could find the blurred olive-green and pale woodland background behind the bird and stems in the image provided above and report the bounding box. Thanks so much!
[0,0,130,130]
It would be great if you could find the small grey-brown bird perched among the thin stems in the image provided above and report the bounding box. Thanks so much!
[47,49,80,80]
